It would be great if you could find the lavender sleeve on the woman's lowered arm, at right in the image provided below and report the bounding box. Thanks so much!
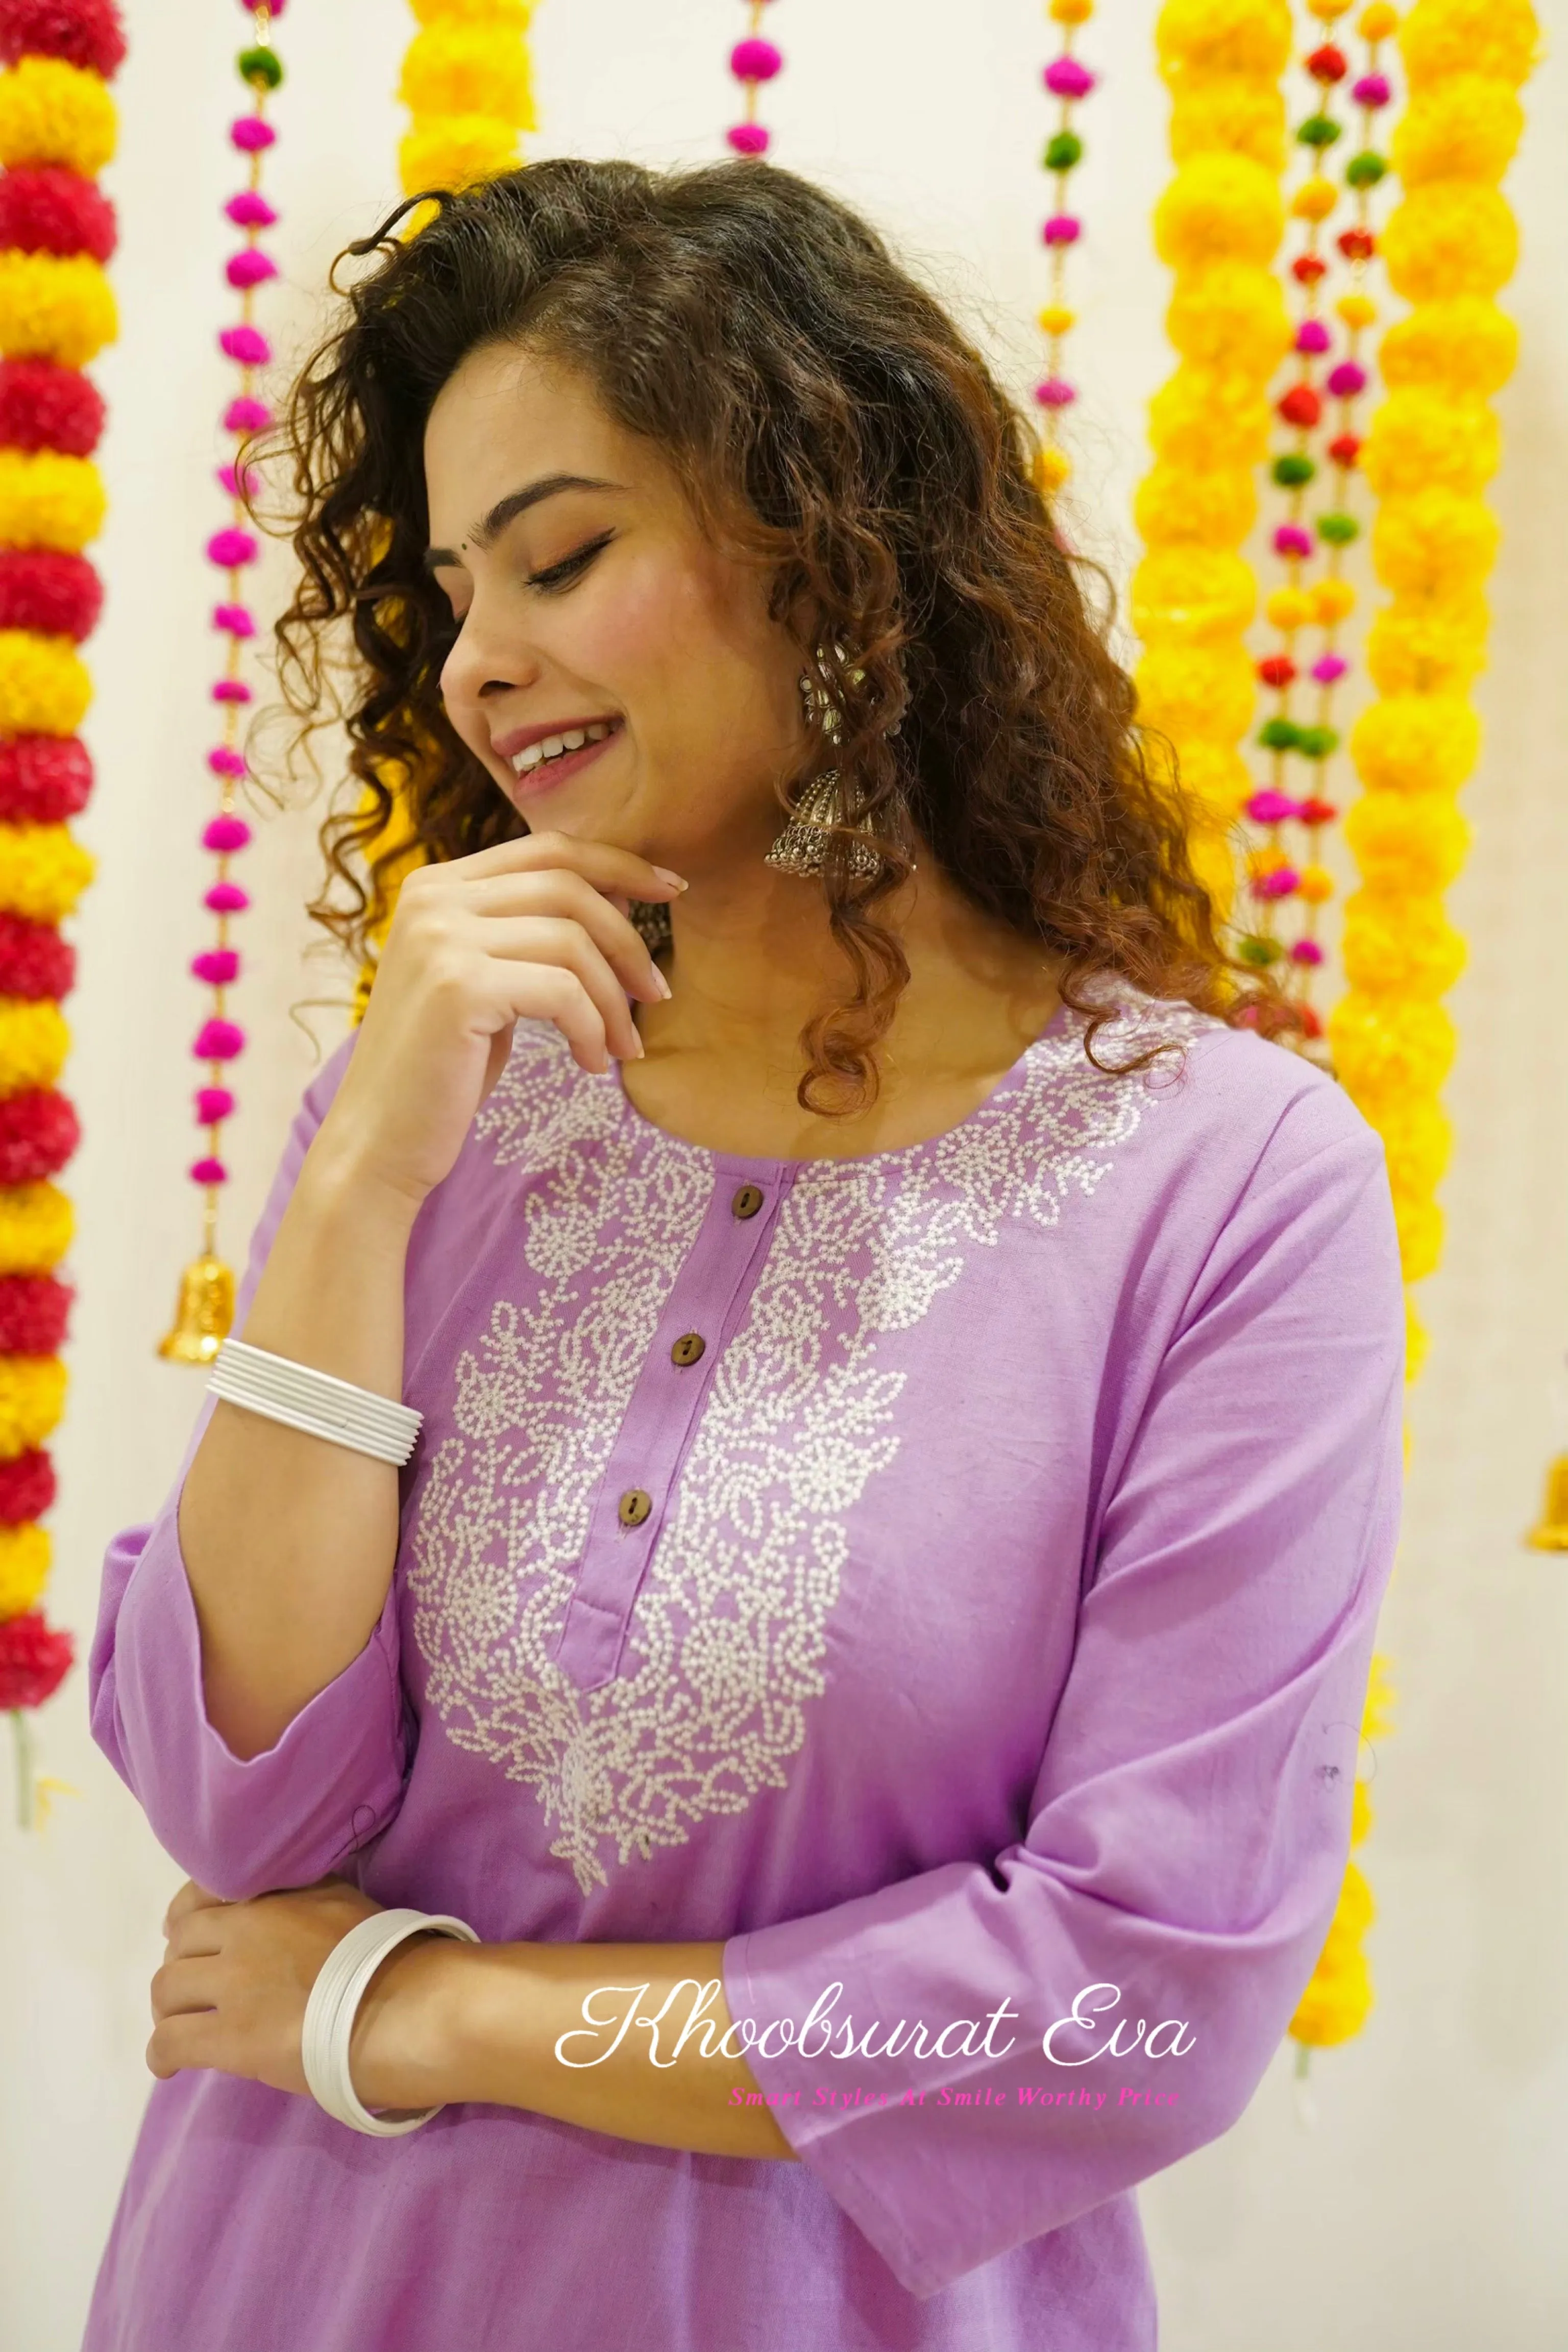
[724,1087,1404,2295]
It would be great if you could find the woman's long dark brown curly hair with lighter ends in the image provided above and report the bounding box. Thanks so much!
[261,160,1300,1115]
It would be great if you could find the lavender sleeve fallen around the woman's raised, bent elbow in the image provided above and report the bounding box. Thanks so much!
[87,1037,404,1900]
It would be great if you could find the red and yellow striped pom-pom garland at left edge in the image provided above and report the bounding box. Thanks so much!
[0,0,125,1827]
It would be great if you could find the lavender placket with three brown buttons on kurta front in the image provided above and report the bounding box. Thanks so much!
[552,1160,792,1691]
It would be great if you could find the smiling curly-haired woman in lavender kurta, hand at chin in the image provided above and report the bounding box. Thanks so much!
[87,162,1404,2352]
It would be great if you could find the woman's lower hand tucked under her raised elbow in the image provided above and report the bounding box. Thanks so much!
[148,1879,397,2096]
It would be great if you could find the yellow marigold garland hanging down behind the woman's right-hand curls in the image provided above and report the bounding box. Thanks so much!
[1131,0,1291,915]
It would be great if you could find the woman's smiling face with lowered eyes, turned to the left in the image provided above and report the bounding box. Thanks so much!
[426,346,802,877]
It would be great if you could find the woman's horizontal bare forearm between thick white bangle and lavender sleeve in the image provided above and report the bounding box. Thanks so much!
[350,1935,795,2157]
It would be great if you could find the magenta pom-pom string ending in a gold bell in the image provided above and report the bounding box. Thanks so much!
[158,0,284,1364]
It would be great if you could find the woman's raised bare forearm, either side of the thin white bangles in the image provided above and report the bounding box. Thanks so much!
[179,1119,419,1757]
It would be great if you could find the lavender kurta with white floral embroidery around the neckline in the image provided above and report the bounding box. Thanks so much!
[85,993,1404,2352]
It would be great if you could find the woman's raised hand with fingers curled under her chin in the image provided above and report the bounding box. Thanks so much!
[313,832,687,1202]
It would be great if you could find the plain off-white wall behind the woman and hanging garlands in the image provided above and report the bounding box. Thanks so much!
[0,0,1568,2352]
